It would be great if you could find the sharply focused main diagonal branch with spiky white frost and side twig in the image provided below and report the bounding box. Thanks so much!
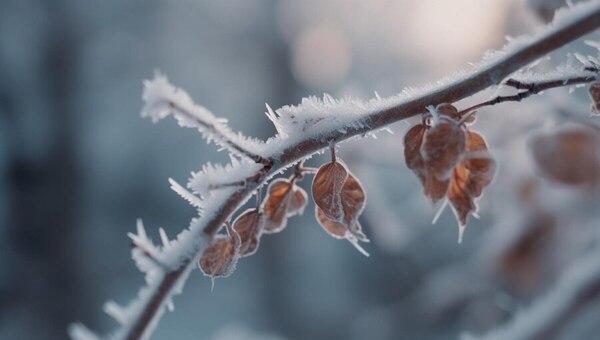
[69,1,600,339]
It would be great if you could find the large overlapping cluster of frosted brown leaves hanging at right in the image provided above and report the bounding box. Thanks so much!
[404,104,496,242]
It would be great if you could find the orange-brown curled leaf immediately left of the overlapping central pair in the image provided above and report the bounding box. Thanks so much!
[262,178,307,233]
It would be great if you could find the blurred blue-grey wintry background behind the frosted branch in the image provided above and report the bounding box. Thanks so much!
[0,0,600,340]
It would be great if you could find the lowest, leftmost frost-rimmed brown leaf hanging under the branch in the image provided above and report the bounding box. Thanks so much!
[198,225,241,279]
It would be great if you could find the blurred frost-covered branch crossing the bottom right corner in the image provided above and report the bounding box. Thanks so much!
[472,248,600,340]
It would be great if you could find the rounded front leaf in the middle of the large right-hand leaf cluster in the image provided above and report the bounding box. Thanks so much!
[421,116,466,180]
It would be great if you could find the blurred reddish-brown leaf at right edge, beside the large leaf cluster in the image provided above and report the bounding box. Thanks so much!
[529,124,600,185]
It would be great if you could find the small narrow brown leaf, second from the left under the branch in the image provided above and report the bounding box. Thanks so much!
[233,209,265,257]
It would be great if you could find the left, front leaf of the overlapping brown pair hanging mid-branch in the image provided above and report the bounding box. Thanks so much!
[312,162,348,221]
